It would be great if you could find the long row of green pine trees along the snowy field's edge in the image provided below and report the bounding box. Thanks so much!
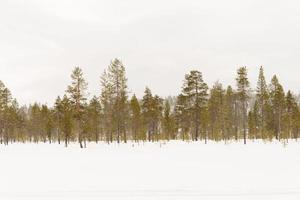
[0,59,300,148]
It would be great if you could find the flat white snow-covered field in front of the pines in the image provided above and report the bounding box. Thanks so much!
[0,142,300,200]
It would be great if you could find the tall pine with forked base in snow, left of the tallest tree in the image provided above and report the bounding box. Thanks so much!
[67,67,87,148]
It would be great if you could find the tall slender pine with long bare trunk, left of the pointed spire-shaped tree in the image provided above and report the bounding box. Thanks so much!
[236,67,250,144]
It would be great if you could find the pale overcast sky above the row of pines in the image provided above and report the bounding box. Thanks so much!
[0,0,300,104]
